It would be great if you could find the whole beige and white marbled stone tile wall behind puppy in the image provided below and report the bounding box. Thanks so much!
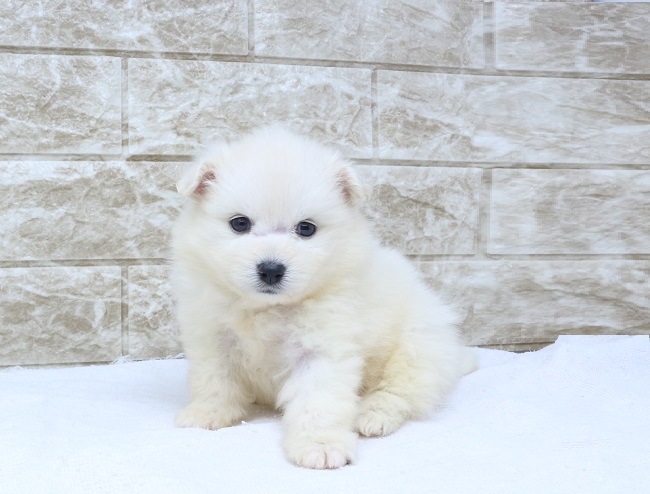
[0,0,650,365]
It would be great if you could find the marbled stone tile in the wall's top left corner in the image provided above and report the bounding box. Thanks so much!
[0,0,248,54]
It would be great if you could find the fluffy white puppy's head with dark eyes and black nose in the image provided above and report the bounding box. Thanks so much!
[174,129,369,307]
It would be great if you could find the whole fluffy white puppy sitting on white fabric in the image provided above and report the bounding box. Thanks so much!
[173,129,474,468]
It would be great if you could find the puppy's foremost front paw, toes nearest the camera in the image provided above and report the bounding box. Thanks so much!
[284,431,357,469]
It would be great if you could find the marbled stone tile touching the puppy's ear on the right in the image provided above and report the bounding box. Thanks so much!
[356,166,481,255]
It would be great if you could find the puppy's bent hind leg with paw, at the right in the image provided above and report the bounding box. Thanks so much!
[357,335,460,436]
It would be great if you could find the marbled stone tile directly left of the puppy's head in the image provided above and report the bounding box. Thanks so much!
[0,161,182,260]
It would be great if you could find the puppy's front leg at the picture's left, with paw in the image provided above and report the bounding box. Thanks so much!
[176,330,253,430]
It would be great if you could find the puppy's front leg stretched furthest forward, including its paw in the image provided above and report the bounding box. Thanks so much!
[278,357,361,469]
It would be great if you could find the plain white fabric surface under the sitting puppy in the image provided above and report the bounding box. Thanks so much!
[0,336,650,494]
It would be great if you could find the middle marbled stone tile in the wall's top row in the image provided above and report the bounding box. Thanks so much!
[255,0,485,68]
